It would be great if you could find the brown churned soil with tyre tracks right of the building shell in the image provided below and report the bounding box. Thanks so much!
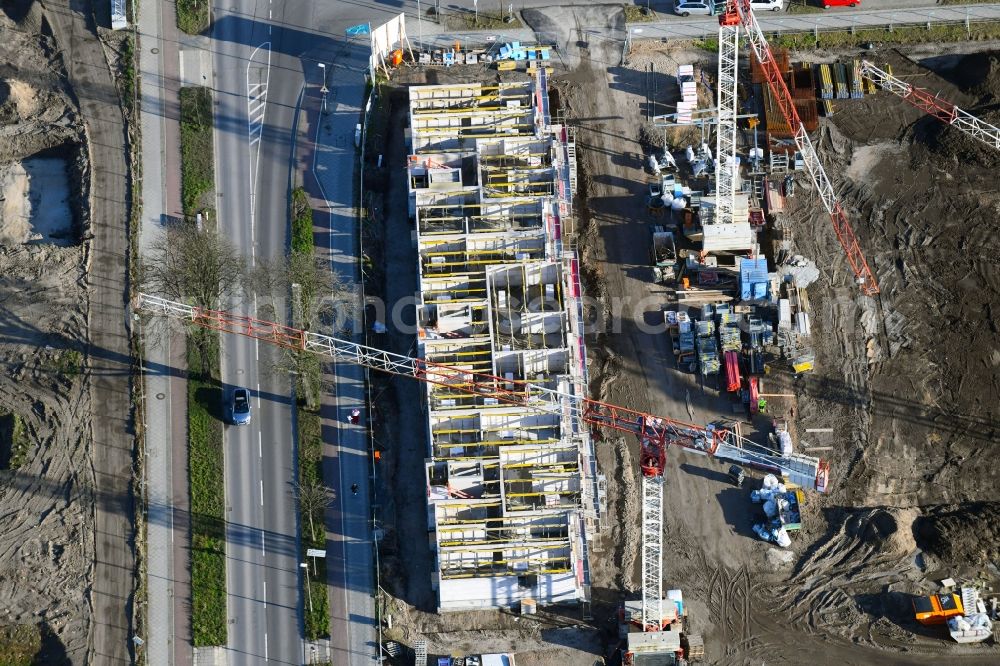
[544,10,1000,664]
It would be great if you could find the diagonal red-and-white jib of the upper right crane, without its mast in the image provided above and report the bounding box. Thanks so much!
[719,0,879,296]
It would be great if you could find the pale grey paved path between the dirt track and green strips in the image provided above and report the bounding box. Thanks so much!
[139,2,192,666]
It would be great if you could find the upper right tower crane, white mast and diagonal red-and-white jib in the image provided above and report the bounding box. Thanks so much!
[717,0,879,296]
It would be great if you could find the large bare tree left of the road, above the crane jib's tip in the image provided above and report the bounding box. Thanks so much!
[140,223,246,309]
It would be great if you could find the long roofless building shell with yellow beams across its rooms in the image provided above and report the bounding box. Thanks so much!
[407,71,602,611]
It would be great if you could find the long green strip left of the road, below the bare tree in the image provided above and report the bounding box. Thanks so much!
[187,330,226,647]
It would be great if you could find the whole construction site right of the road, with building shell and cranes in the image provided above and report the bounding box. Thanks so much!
[346,5,1000,664]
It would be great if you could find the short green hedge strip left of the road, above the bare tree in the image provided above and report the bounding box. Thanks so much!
[180,86,215,219]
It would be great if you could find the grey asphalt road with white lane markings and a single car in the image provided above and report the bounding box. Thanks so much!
[211,0,305,664]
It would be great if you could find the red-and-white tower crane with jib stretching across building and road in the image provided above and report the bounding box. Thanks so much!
[133,294,830,631]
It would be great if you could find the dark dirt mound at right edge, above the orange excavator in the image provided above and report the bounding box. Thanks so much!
[913,502,1000,565]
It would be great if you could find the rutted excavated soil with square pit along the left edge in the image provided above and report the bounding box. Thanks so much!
[0,2,96,663]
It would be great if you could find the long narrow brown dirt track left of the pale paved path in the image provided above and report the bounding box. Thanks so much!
[43,0,135,664]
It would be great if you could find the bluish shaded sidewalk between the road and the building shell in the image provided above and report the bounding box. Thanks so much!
[296,42,377,665]
